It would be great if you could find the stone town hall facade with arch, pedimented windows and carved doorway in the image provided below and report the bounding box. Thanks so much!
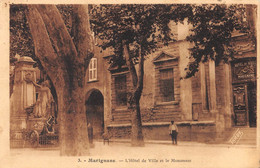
[86,20,257,142]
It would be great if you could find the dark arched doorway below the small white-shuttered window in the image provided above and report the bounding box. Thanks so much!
[85,89,104,139]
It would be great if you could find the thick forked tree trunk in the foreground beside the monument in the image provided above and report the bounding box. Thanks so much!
[27,5,92,156]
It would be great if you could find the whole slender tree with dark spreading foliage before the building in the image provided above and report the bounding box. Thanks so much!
[91,4,250,146]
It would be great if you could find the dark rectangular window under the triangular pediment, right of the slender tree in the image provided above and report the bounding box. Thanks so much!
[159,68,174,102]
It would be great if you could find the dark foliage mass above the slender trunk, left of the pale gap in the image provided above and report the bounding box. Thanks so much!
[90,4,185,65]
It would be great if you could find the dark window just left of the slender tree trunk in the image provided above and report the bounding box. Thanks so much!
[115,75,127,106]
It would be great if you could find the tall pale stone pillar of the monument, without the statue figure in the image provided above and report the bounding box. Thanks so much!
[10,57,36,148]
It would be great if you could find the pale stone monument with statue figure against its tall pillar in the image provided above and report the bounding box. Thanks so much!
[10,56,54,147]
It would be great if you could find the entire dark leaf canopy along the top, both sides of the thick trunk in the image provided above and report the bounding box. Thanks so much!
[10,4,251,77]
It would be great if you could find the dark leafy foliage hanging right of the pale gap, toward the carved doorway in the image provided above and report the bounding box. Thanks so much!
[184,5,248,77]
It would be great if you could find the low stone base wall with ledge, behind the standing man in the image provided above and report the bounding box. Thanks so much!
[108,122,216,142]
